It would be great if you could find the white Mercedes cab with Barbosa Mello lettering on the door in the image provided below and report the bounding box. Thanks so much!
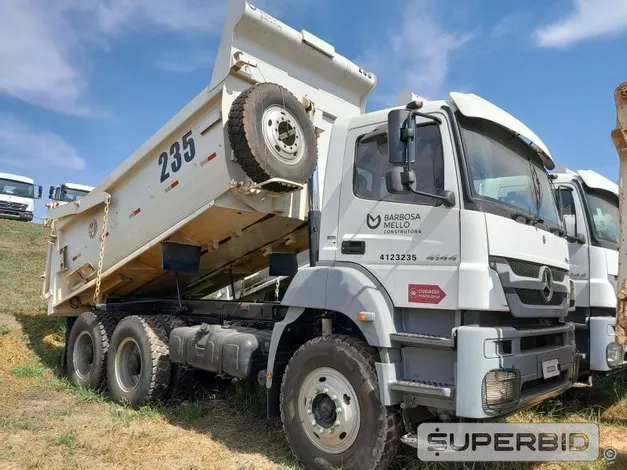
[275,93,577,430]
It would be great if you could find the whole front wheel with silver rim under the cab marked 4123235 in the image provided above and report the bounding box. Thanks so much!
[281,335,401,470]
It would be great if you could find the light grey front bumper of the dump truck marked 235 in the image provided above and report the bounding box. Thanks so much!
[455,323,578,419]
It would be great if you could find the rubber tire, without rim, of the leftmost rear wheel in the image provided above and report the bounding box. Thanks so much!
[65,312,119,389]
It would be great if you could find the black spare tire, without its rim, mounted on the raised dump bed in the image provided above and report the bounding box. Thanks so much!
[228,83,318,192]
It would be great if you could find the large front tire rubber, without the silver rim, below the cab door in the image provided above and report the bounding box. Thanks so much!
[281,335,402,470]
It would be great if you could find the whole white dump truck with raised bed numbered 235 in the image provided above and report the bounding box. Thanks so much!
[44,0,577,469]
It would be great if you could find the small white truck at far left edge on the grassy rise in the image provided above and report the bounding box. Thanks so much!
[0,172,42,222]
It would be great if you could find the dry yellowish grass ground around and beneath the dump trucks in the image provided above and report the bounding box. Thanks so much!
[0,220,627,470]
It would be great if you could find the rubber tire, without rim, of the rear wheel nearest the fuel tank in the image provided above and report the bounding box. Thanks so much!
[107,315,172,408]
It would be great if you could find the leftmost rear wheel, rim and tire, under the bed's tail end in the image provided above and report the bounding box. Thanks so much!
[66,312,117,389]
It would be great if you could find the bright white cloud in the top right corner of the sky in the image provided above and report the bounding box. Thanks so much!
[533,0,627,48]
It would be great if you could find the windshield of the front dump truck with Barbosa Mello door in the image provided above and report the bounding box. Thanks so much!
[459,116,559,226]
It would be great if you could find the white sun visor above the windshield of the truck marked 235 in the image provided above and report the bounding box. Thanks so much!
[450,92,555,170]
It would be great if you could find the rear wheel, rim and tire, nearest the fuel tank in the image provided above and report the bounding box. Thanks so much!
[107,315,171,407]
